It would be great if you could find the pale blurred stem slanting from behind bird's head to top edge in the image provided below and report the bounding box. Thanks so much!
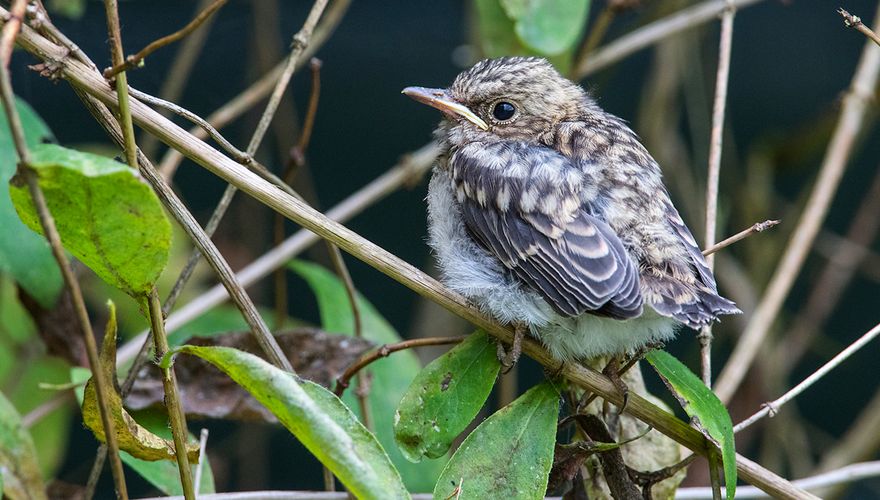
[573,0,761,80]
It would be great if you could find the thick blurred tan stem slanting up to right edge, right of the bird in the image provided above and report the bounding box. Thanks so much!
[715,9,880,402]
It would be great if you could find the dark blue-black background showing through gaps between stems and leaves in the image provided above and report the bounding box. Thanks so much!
[12,0,880,498]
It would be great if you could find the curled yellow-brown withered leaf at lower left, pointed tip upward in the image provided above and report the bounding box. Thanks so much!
[82,303,199,463]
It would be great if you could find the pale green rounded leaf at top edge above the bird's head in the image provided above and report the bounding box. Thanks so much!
[500,0,590,56]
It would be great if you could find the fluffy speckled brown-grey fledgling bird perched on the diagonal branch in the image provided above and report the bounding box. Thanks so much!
[403,57,740,361]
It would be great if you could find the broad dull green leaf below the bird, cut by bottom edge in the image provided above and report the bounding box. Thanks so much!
[434,382,559,500]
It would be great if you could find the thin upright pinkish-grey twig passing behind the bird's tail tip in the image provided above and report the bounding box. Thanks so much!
[697,0,736,387]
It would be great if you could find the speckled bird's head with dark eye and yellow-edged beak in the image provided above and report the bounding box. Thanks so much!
[403,57,595,145]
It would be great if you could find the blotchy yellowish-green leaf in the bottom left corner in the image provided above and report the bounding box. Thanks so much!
[0,393,46,499]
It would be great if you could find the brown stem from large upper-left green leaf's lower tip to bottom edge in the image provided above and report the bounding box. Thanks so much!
[147,288,195,500]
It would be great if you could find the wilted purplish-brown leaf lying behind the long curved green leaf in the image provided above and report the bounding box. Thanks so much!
[125,328,373,422]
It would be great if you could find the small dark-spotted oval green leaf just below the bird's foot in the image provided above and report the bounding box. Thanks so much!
[394,331,501,462]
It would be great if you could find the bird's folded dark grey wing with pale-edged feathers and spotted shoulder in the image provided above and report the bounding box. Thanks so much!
[449,141,642,319]
